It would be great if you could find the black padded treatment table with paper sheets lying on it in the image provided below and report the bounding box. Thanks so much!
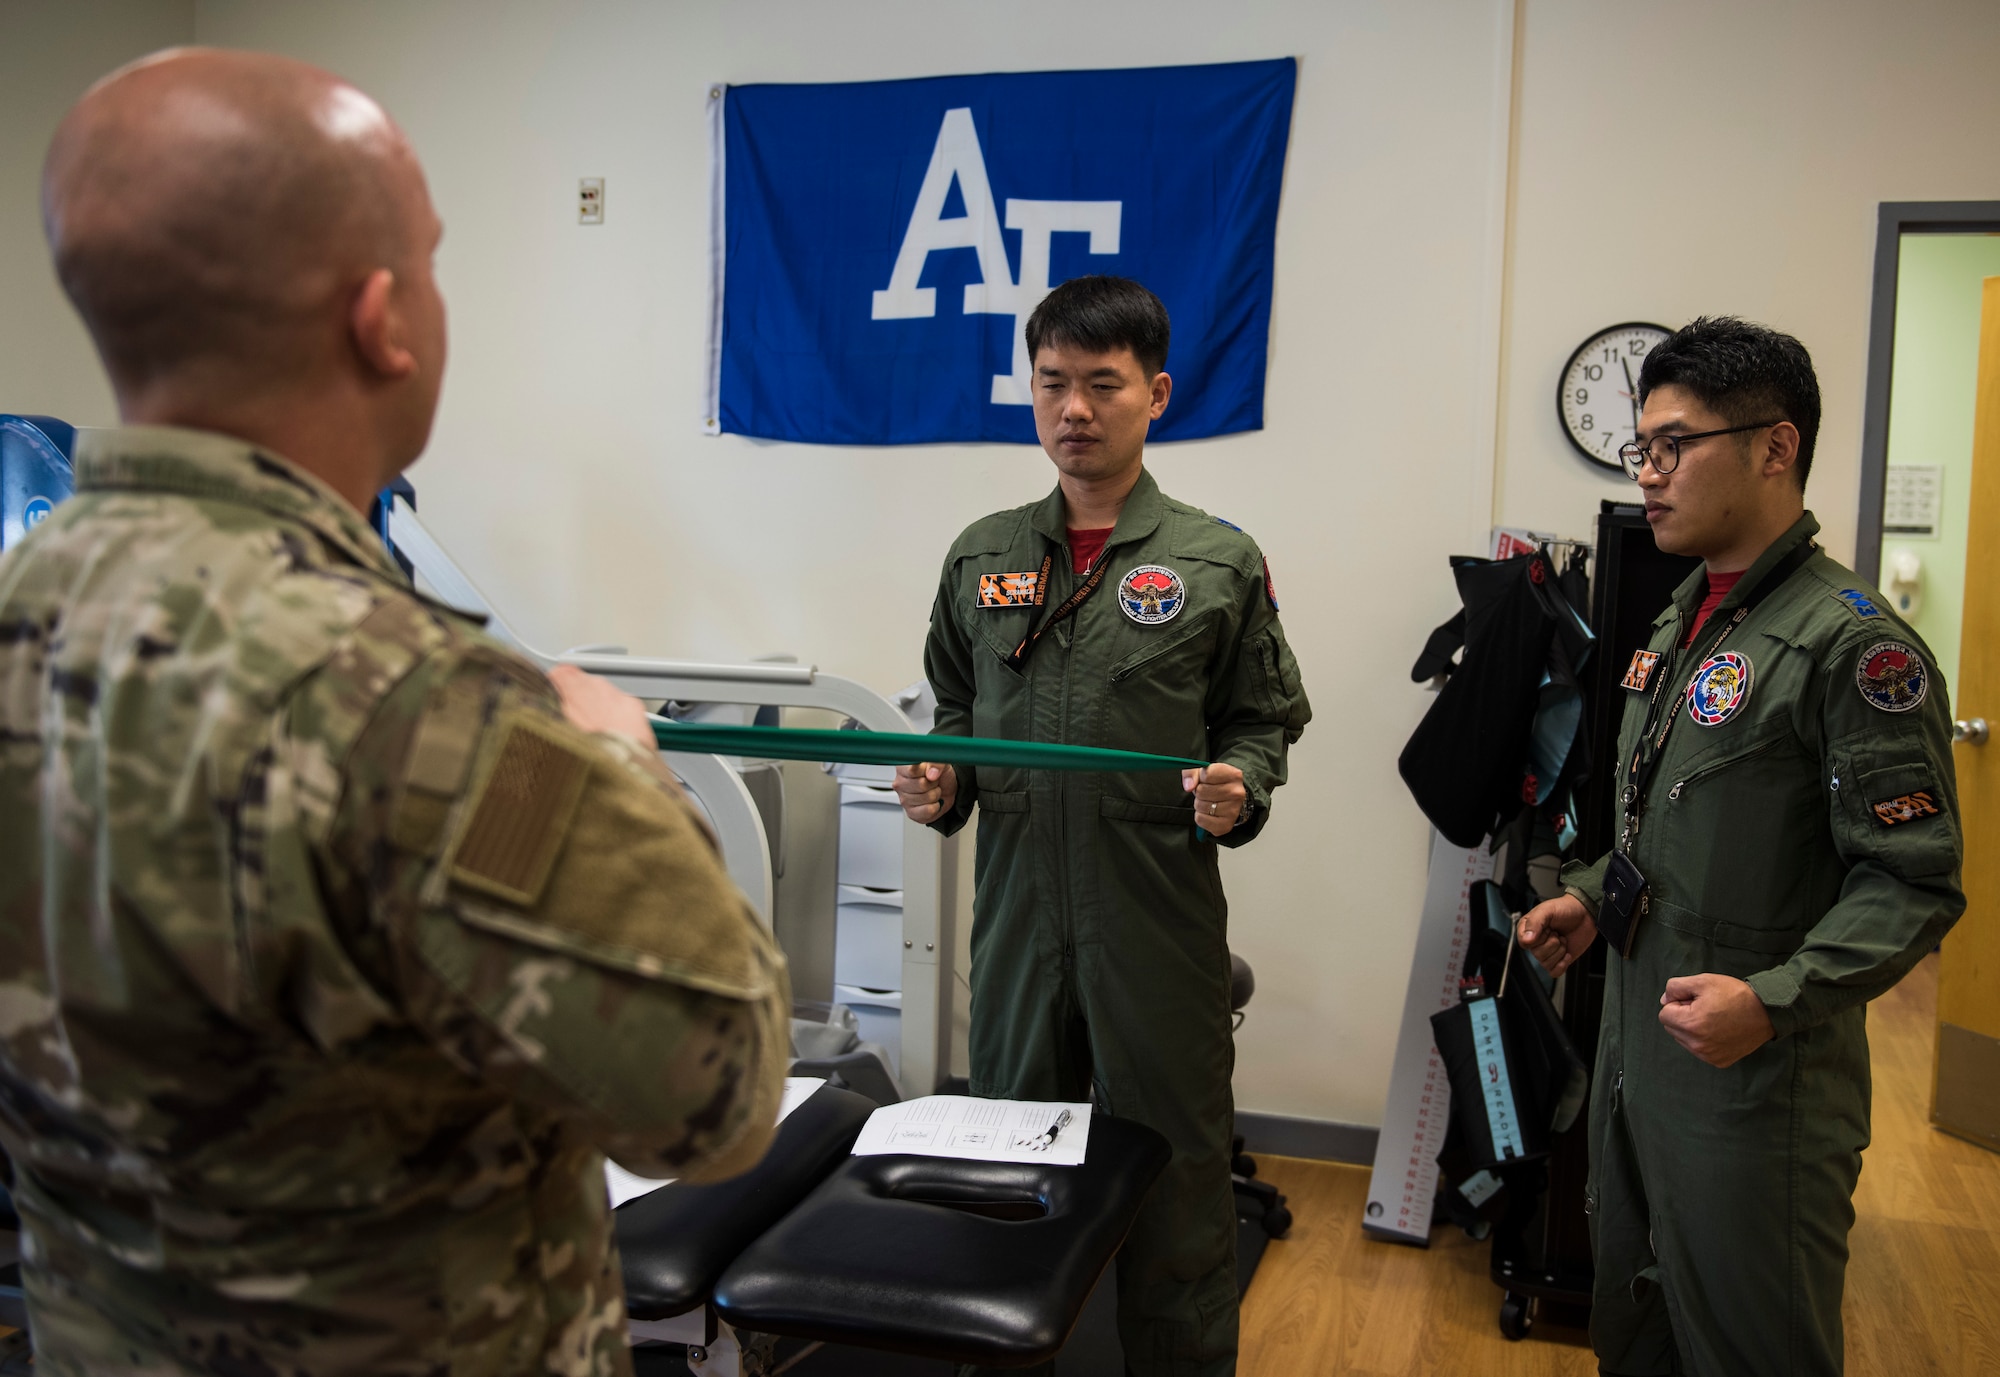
[614,1087,1170,1377]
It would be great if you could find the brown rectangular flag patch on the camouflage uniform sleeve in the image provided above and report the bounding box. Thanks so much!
[452,713,590,907]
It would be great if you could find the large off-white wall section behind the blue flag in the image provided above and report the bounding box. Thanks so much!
[198,0,1512,1123]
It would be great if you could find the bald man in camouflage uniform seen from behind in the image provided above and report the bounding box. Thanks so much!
[0,50,790,1377]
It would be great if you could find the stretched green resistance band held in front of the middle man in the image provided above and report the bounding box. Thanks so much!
[652,717,1208,773]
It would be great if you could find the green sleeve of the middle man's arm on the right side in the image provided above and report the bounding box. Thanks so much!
[1202,564,1312,847]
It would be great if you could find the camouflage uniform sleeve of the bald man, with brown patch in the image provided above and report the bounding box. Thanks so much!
[294,608,790,1179]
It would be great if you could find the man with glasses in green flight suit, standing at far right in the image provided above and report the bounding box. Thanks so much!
[1520,318,1964,1377]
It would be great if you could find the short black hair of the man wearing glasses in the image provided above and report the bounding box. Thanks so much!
[1638,316,1820,488]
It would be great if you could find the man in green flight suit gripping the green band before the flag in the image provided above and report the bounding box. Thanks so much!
[896,276,1312,1377]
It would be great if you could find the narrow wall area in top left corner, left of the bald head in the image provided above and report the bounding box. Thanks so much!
[0,0,194,426]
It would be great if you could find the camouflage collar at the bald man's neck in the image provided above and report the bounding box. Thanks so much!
[76,426,406,582]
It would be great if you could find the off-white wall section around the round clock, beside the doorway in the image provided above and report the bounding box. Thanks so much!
[1496,0,2000,560]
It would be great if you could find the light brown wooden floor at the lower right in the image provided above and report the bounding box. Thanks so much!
[1240,957,2000,1377]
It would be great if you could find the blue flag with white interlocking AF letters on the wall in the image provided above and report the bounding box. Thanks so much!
[708,58,1296,444]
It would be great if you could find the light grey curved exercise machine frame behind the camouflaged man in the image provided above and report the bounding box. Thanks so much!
[388,496,958,1095]
